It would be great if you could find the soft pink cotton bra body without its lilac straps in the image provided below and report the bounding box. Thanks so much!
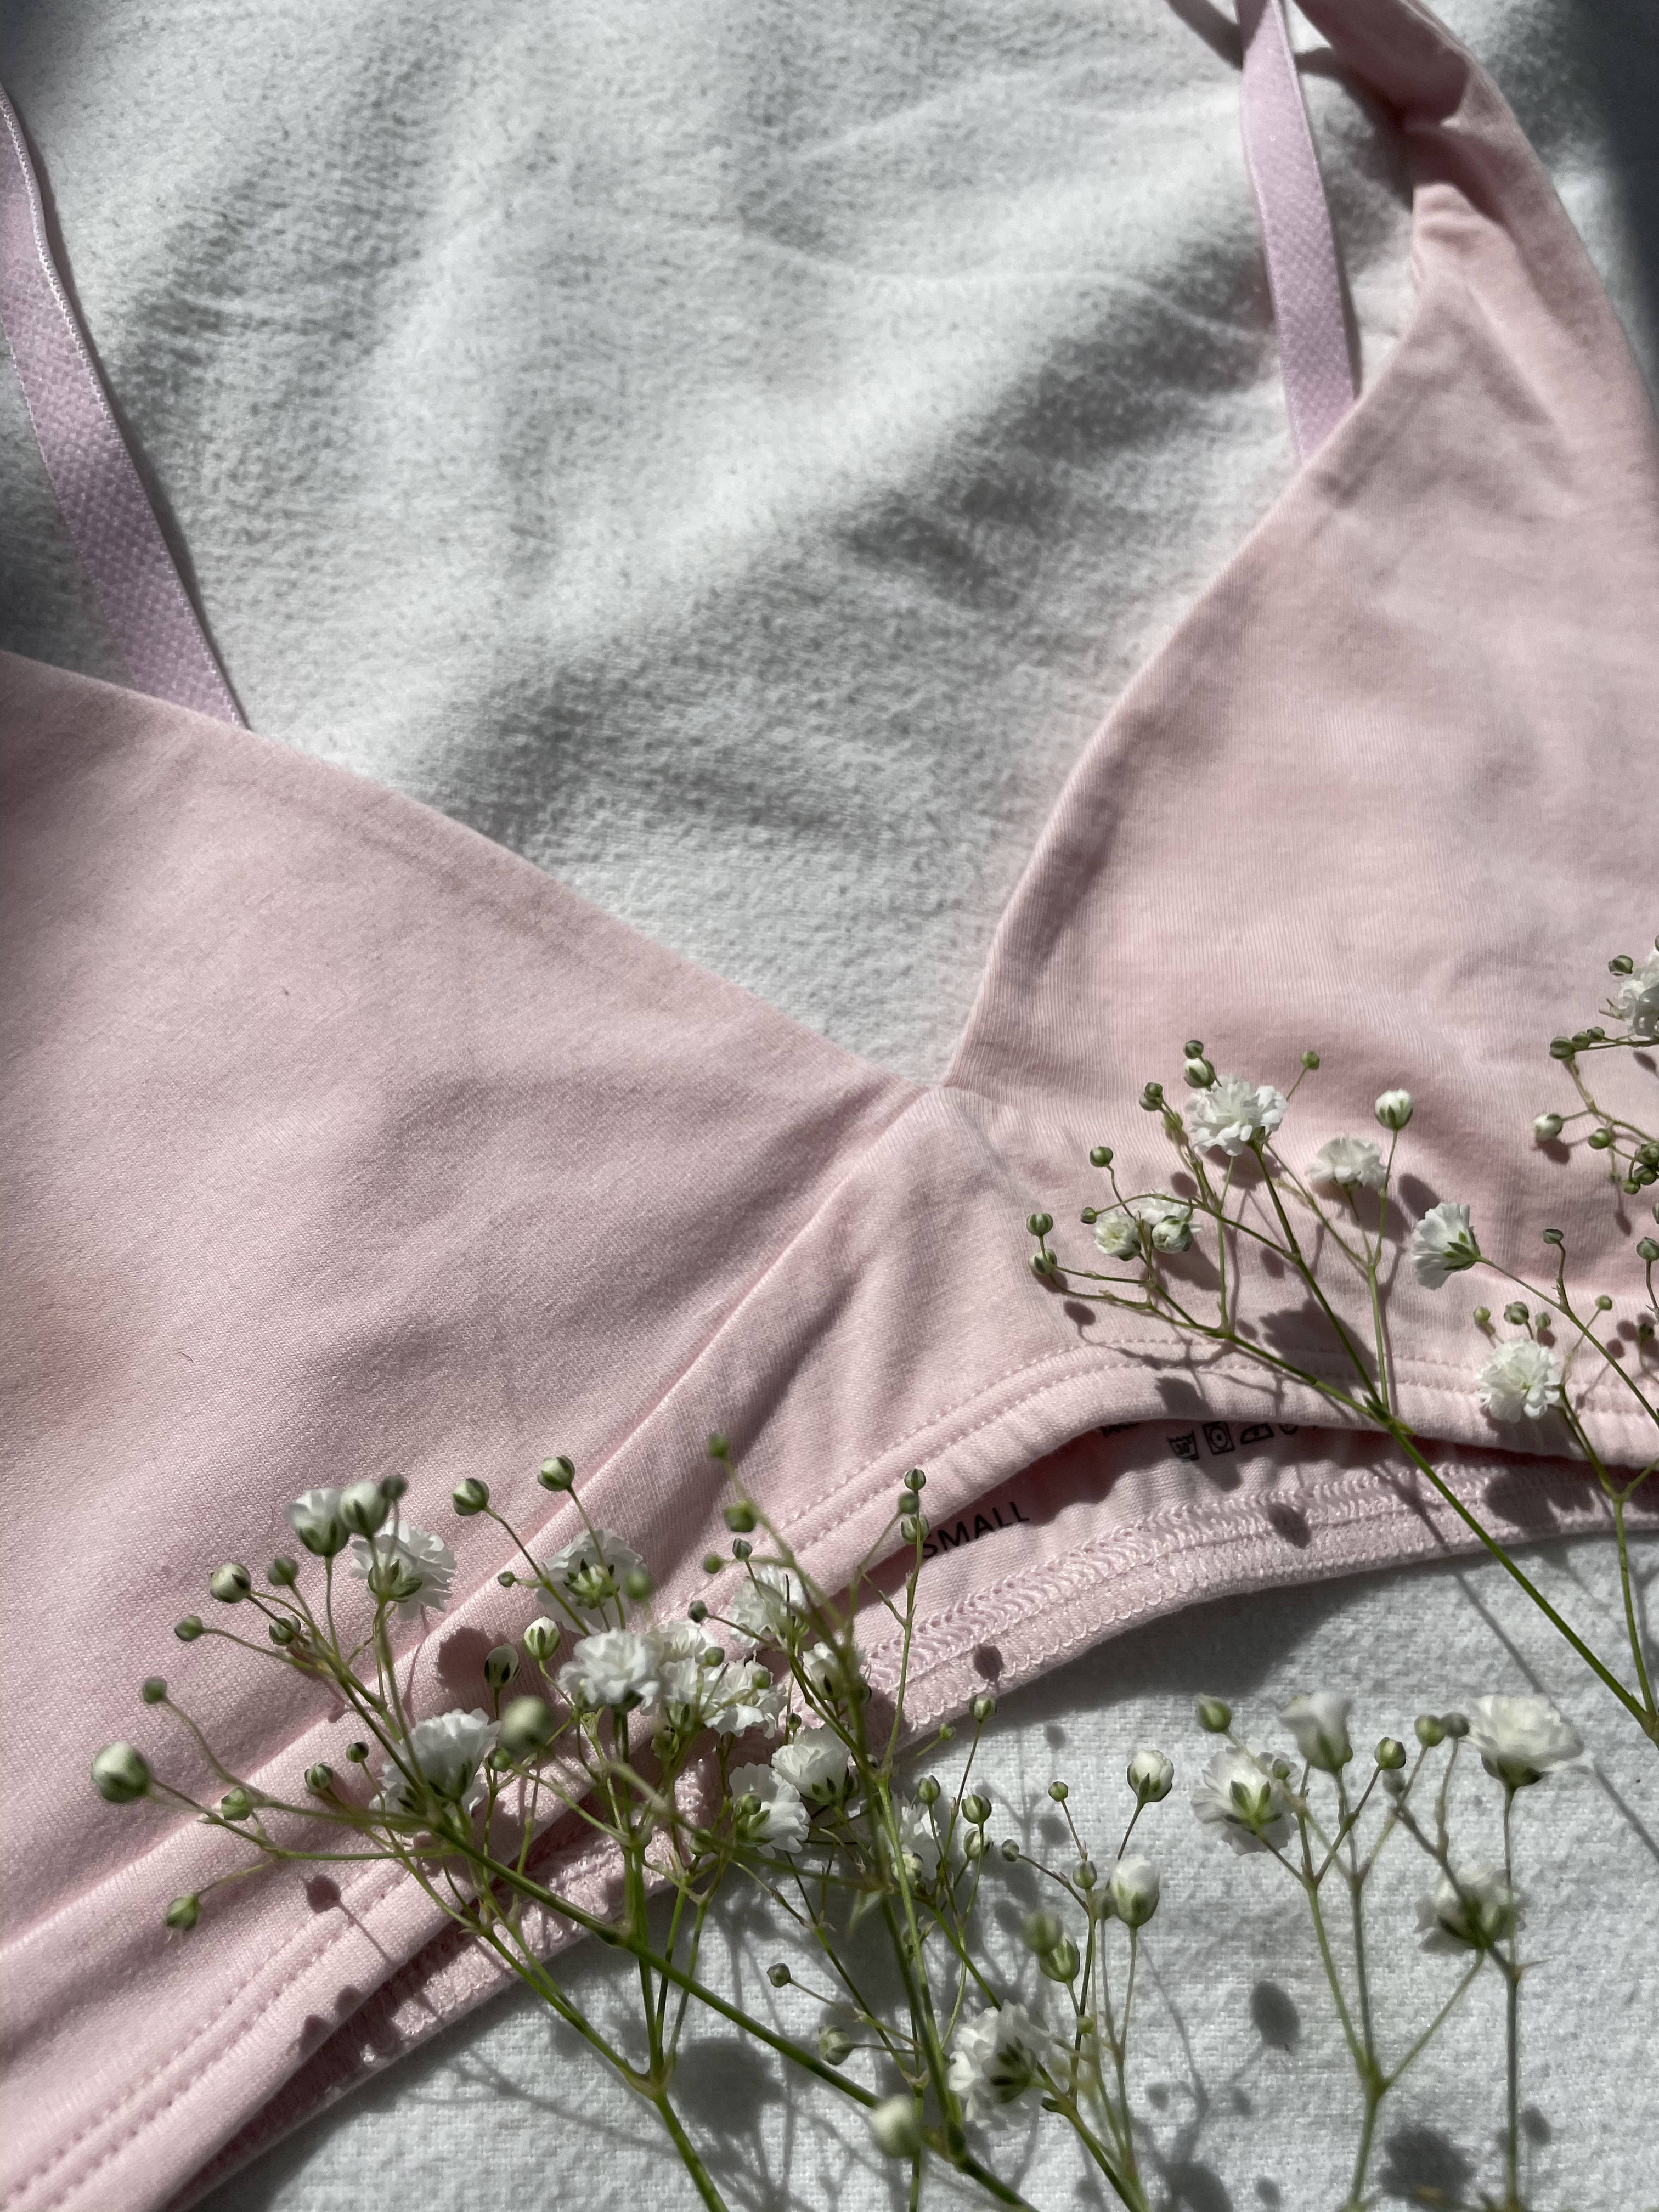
[0,0,1659,2212]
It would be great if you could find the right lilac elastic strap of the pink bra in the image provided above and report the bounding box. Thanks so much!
[1239,0,1354,460]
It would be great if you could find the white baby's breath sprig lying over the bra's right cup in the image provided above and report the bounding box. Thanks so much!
[1026,951,1659,1745]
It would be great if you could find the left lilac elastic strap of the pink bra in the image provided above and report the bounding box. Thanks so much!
[0,91,241,723]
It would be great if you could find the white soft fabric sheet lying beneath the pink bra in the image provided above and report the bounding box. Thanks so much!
[0,0,1659,2212]
